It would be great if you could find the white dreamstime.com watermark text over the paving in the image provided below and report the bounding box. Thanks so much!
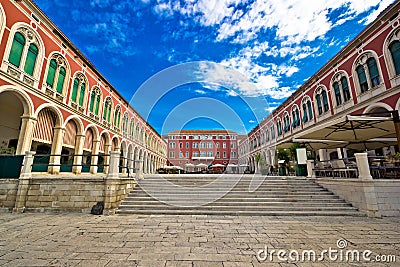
[257,238,396,263]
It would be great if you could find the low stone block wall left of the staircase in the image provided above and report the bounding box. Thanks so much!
[0,175,136,213]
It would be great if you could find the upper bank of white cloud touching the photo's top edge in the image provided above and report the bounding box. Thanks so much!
[155,0,393,44]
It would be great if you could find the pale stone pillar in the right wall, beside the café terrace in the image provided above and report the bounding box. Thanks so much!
[354,153,381,218]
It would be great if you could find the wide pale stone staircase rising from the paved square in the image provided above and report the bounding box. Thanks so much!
[116,175,364,216]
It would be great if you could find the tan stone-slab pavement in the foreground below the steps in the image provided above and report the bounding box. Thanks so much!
[0,213,400,267]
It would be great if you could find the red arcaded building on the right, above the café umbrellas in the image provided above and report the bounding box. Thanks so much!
[239,2,400,171]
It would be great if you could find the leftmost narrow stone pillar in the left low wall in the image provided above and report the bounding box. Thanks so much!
[14,151,36,213]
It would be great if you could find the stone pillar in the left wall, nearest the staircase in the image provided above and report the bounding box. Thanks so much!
[103,151,120,215]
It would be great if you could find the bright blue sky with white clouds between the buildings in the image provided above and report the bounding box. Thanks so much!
[35,0,394,134]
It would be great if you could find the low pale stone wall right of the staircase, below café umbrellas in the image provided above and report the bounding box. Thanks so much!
[315,178,400,216]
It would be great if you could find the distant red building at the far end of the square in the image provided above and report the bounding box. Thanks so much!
[167,130,239,172]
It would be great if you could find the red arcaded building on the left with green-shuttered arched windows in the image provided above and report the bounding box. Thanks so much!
[0,0,167,173]
